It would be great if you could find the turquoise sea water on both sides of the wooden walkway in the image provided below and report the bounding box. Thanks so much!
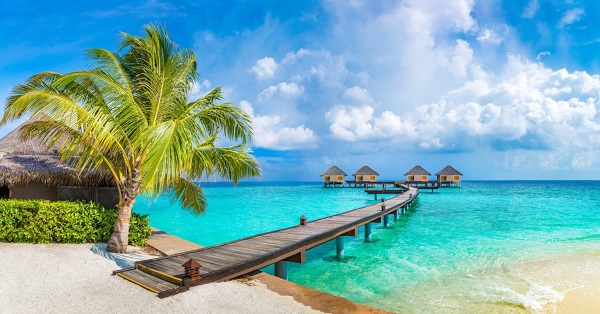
[134,181,600,313]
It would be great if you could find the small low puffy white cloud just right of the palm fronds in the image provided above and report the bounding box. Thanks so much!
[240,101,317,151]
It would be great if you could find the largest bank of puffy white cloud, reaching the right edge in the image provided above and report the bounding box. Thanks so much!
[326,55,600,161]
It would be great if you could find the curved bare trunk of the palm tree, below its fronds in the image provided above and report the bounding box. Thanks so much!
[106,179,140,253]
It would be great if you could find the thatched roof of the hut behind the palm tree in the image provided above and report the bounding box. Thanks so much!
[0,119,112,186]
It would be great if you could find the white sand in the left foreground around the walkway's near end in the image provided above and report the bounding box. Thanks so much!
[0,243,321,313]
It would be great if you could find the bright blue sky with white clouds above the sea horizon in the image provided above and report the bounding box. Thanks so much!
[0,0,600,181]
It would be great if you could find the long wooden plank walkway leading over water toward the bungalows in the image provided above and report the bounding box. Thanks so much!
[113,187,419,298]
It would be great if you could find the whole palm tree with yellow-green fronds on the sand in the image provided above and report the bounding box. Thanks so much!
[0,25,260,252]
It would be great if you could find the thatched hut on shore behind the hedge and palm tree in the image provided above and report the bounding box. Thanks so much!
[0,120,119,207]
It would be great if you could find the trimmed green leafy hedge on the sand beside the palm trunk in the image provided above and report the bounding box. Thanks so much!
[0,199,151,246]
